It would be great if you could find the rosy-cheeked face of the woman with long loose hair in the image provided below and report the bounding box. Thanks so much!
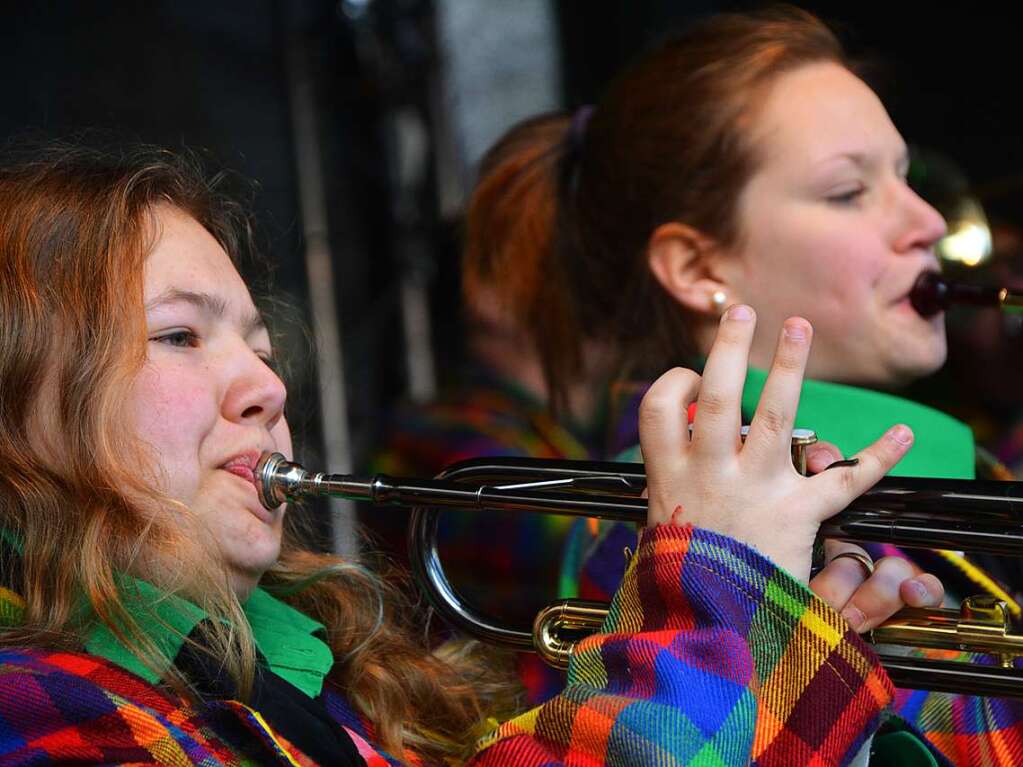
[126,206,292,596]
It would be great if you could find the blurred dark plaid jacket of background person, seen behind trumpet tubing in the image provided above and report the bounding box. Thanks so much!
[363,368,599,620]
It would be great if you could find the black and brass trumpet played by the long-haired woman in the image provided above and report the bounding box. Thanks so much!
[256,454,1023,698]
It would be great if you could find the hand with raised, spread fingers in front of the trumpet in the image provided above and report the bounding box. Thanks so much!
[639,305,913,583]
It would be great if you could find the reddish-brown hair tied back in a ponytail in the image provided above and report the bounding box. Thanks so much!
[463,7,846,405]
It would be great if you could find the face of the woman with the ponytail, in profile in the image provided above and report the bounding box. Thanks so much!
[720,63,945,387]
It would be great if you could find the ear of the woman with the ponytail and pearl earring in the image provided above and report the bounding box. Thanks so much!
[647,223,735,317]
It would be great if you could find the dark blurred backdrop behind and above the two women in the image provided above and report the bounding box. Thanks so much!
[0,0,1023,552]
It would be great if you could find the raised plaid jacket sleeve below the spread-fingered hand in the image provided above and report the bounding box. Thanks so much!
[470,526,893,767]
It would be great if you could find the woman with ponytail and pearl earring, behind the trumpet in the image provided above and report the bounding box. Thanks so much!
[465,9,1023,763]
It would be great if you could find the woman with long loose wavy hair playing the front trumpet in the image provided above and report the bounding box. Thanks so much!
[0,140,908,766]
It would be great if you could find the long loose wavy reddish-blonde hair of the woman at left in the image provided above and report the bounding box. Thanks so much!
[0,145,515,763]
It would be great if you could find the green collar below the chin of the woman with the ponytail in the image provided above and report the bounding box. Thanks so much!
[743,368,975,480]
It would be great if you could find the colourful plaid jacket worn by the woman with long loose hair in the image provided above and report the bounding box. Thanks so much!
[0,527,892,767]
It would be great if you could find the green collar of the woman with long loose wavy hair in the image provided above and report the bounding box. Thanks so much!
[85,577,333,697]
